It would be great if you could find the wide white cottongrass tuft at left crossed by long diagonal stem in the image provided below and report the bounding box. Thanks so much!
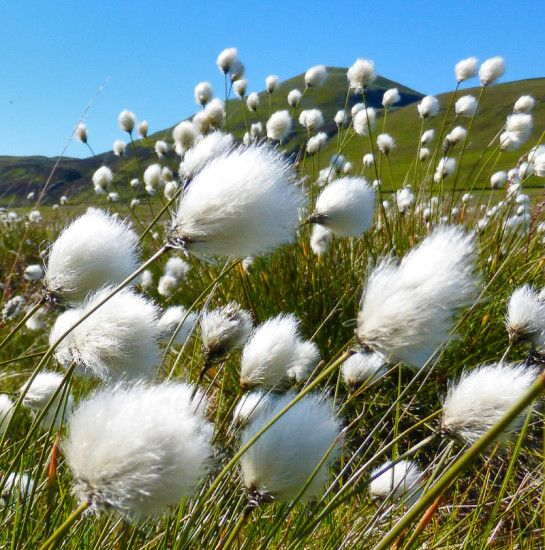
[49,287,160,381]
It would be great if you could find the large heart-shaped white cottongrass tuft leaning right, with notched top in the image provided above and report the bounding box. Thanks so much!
[356,225,480,368]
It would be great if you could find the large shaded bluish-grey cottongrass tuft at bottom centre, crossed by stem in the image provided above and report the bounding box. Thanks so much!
[240,393,340,504]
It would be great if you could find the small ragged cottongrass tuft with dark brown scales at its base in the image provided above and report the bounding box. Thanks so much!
[200,302,253,364]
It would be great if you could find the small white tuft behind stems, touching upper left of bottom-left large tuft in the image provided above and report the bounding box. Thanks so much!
[20,370,74,428]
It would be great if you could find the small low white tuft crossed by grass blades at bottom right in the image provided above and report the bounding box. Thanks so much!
[369,460,423,506]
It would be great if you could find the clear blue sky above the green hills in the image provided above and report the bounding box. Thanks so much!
[0,0,545,156]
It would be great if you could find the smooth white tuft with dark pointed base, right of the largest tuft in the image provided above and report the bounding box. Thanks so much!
[309,177,375,237]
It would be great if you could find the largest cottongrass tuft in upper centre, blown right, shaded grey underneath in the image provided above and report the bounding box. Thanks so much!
[170,145,304,258]
